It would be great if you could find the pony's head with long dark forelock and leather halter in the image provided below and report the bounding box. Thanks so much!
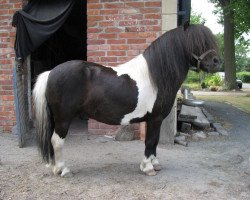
[184,25,221,73]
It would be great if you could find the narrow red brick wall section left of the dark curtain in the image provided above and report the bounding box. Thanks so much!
[0,0,22,132]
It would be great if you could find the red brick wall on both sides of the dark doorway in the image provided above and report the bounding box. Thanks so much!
[0,0,162,134]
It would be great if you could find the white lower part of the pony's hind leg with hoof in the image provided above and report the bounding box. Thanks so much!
[51,132,71,177]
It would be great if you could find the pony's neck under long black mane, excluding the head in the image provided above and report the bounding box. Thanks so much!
[143,28,189,95]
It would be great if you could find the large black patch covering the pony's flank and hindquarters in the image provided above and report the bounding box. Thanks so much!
[46,61,138,130]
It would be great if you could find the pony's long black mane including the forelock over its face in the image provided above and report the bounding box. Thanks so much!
[143,25,217,98]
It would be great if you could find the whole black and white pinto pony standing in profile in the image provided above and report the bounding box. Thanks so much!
[33,24,220,177]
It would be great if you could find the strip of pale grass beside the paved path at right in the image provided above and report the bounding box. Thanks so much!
[196,94,250,114]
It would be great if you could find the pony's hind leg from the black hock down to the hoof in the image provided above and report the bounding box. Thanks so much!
[51,122,72,177]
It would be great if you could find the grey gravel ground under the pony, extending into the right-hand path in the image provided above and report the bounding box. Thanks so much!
[0,103,250,200]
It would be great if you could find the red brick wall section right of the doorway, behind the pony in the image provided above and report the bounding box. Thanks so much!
[87,0,162,134]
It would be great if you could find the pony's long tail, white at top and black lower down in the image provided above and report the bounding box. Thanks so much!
[33,71,54,163]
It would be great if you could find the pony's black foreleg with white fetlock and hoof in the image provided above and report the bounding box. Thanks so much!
[140,118,162,176]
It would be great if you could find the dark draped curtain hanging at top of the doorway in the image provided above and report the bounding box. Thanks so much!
[12,0,75,60]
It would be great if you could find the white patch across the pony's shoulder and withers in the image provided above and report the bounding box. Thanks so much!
[112,54,157,125]
